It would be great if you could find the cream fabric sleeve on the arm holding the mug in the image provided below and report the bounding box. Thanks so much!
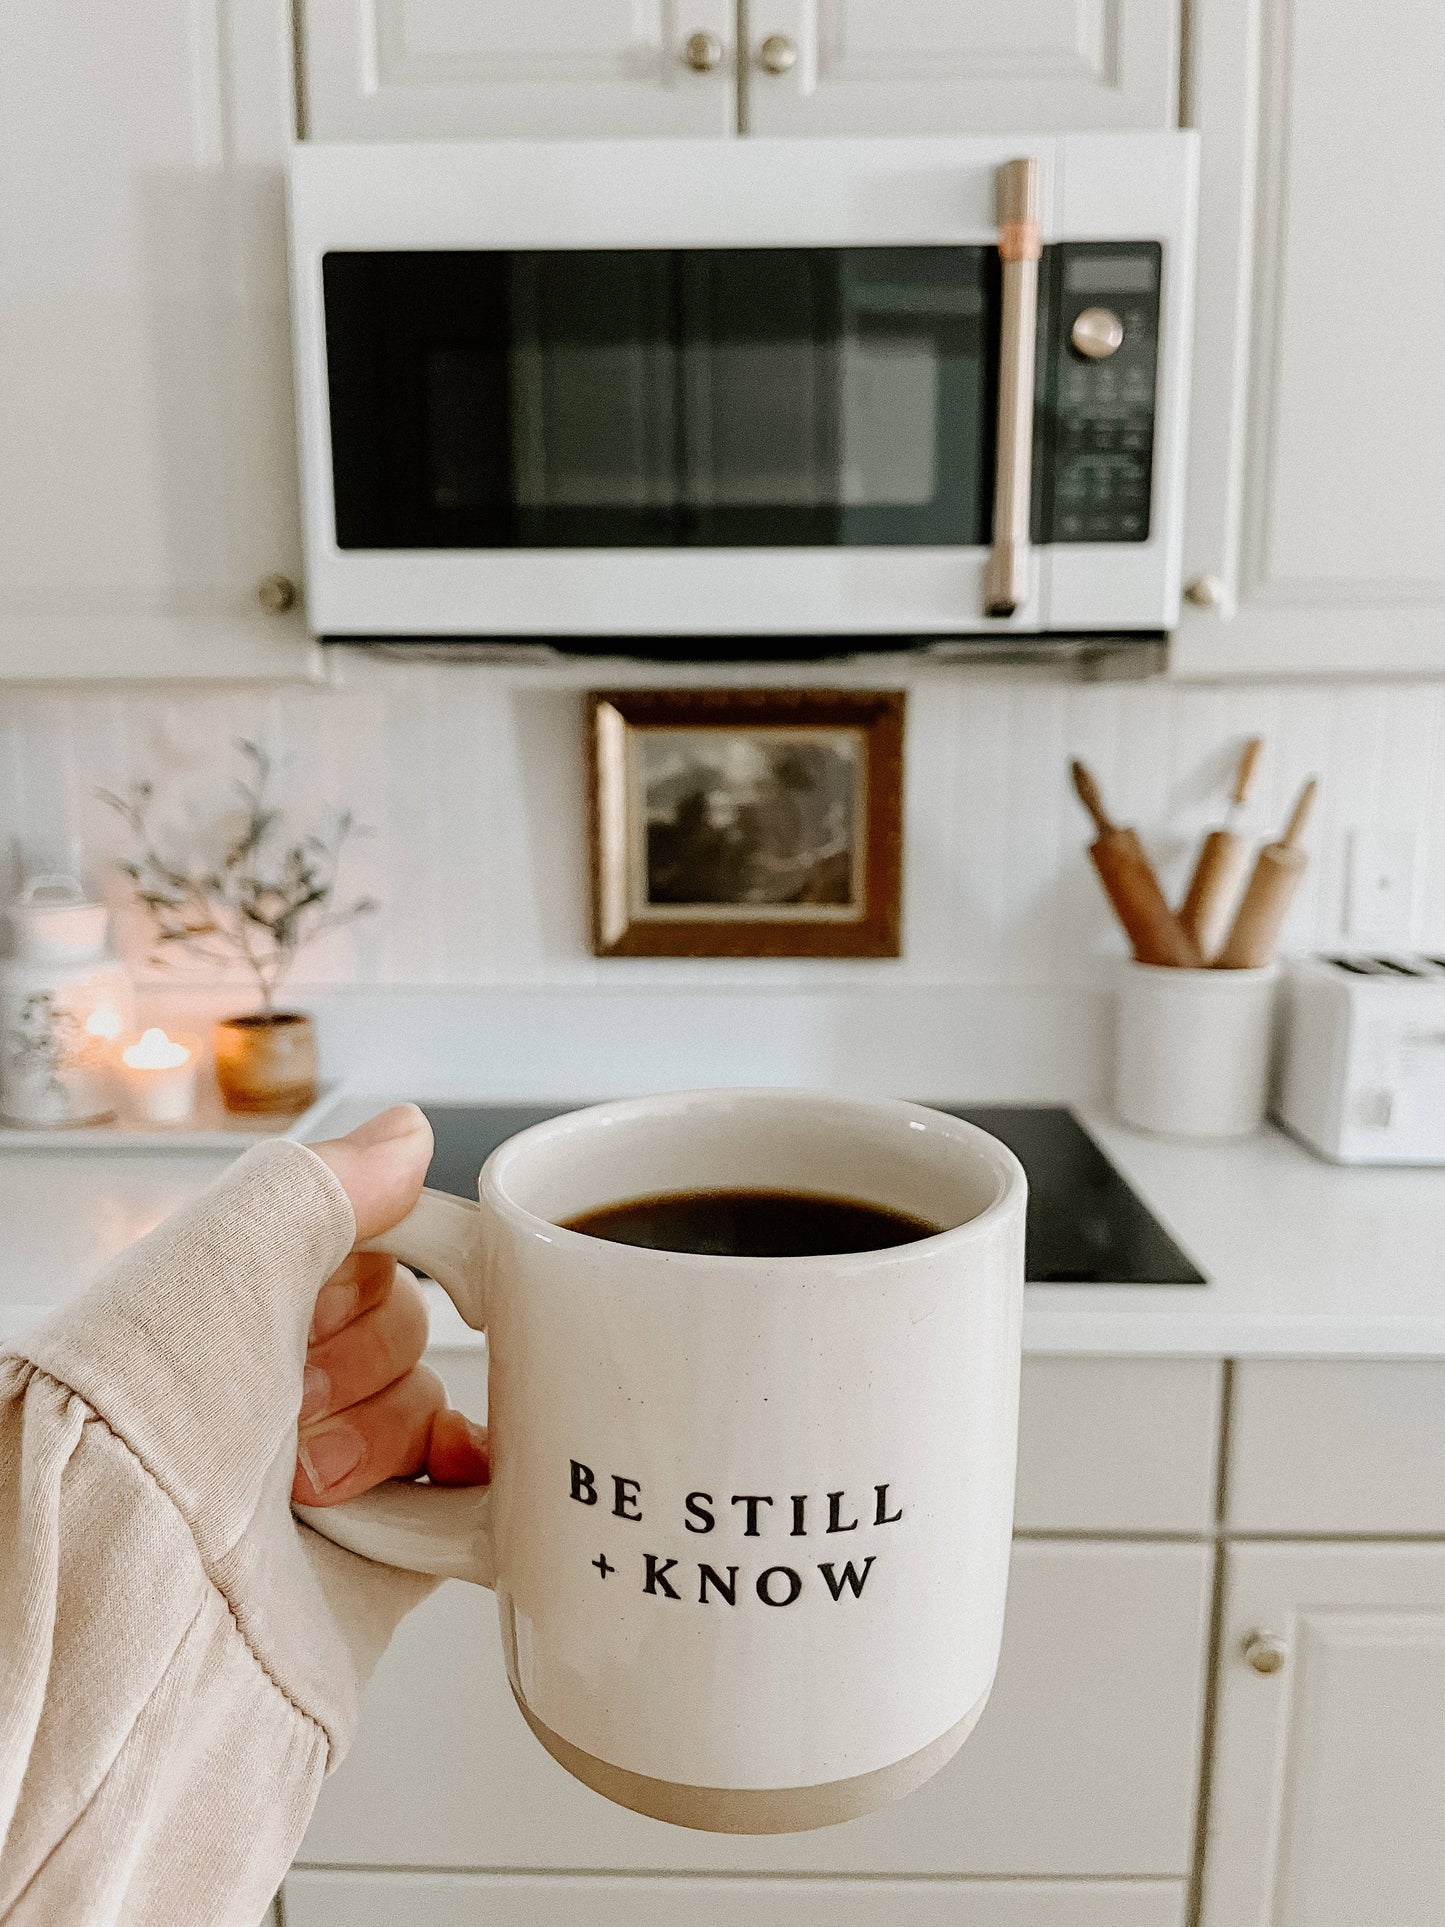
[0,1143,434,1927]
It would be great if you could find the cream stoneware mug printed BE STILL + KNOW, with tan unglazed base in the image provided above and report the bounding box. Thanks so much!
[299,1091,1025,1833]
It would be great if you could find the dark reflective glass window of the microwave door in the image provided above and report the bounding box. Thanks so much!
[324,247,998,549]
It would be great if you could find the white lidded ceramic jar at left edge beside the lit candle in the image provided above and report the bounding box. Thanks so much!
[0,877,135,1127]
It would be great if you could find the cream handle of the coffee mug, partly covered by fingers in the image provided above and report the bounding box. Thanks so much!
[291,1191,495,1586]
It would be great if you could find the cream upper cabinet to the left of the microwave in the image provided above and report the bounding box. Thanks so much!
[0,0,312,678]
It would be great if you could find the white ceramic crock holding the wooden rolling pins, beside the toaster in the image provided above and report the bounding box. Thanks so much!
[1114,964,1275,1137]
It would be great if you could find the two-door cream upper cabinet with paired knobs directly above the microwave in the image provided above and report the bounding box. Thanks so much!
[302,0,1179,141]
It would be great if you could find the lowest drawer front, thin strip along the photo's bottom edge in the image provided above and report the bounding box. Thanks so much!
[285,1873,1185,1927]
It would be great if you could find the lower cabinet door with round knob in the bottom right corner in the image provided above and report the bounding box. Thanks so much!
[1202,1545,1445,1927]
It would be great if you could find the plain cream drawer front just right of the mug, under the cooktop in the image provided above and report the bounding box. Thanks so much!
[1013,1359,1223,1532]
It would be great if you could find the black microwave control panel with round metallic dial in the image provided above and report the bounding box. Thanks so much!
[1033,241,1164,543]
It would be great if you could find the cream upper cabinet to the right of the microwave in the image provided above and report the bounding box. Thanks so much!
[1173,0,1445,674]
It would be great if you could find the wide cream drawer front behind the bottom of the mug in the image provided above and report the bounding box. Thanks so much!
[299,1542,1214,1877]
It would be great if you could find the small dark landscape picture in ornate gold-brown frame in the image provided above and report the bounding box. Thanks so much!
[588,690,904,958]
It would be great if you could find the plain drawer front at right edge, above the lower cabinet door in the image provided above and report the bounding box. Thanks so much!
[1227,1359,1445,1534]
